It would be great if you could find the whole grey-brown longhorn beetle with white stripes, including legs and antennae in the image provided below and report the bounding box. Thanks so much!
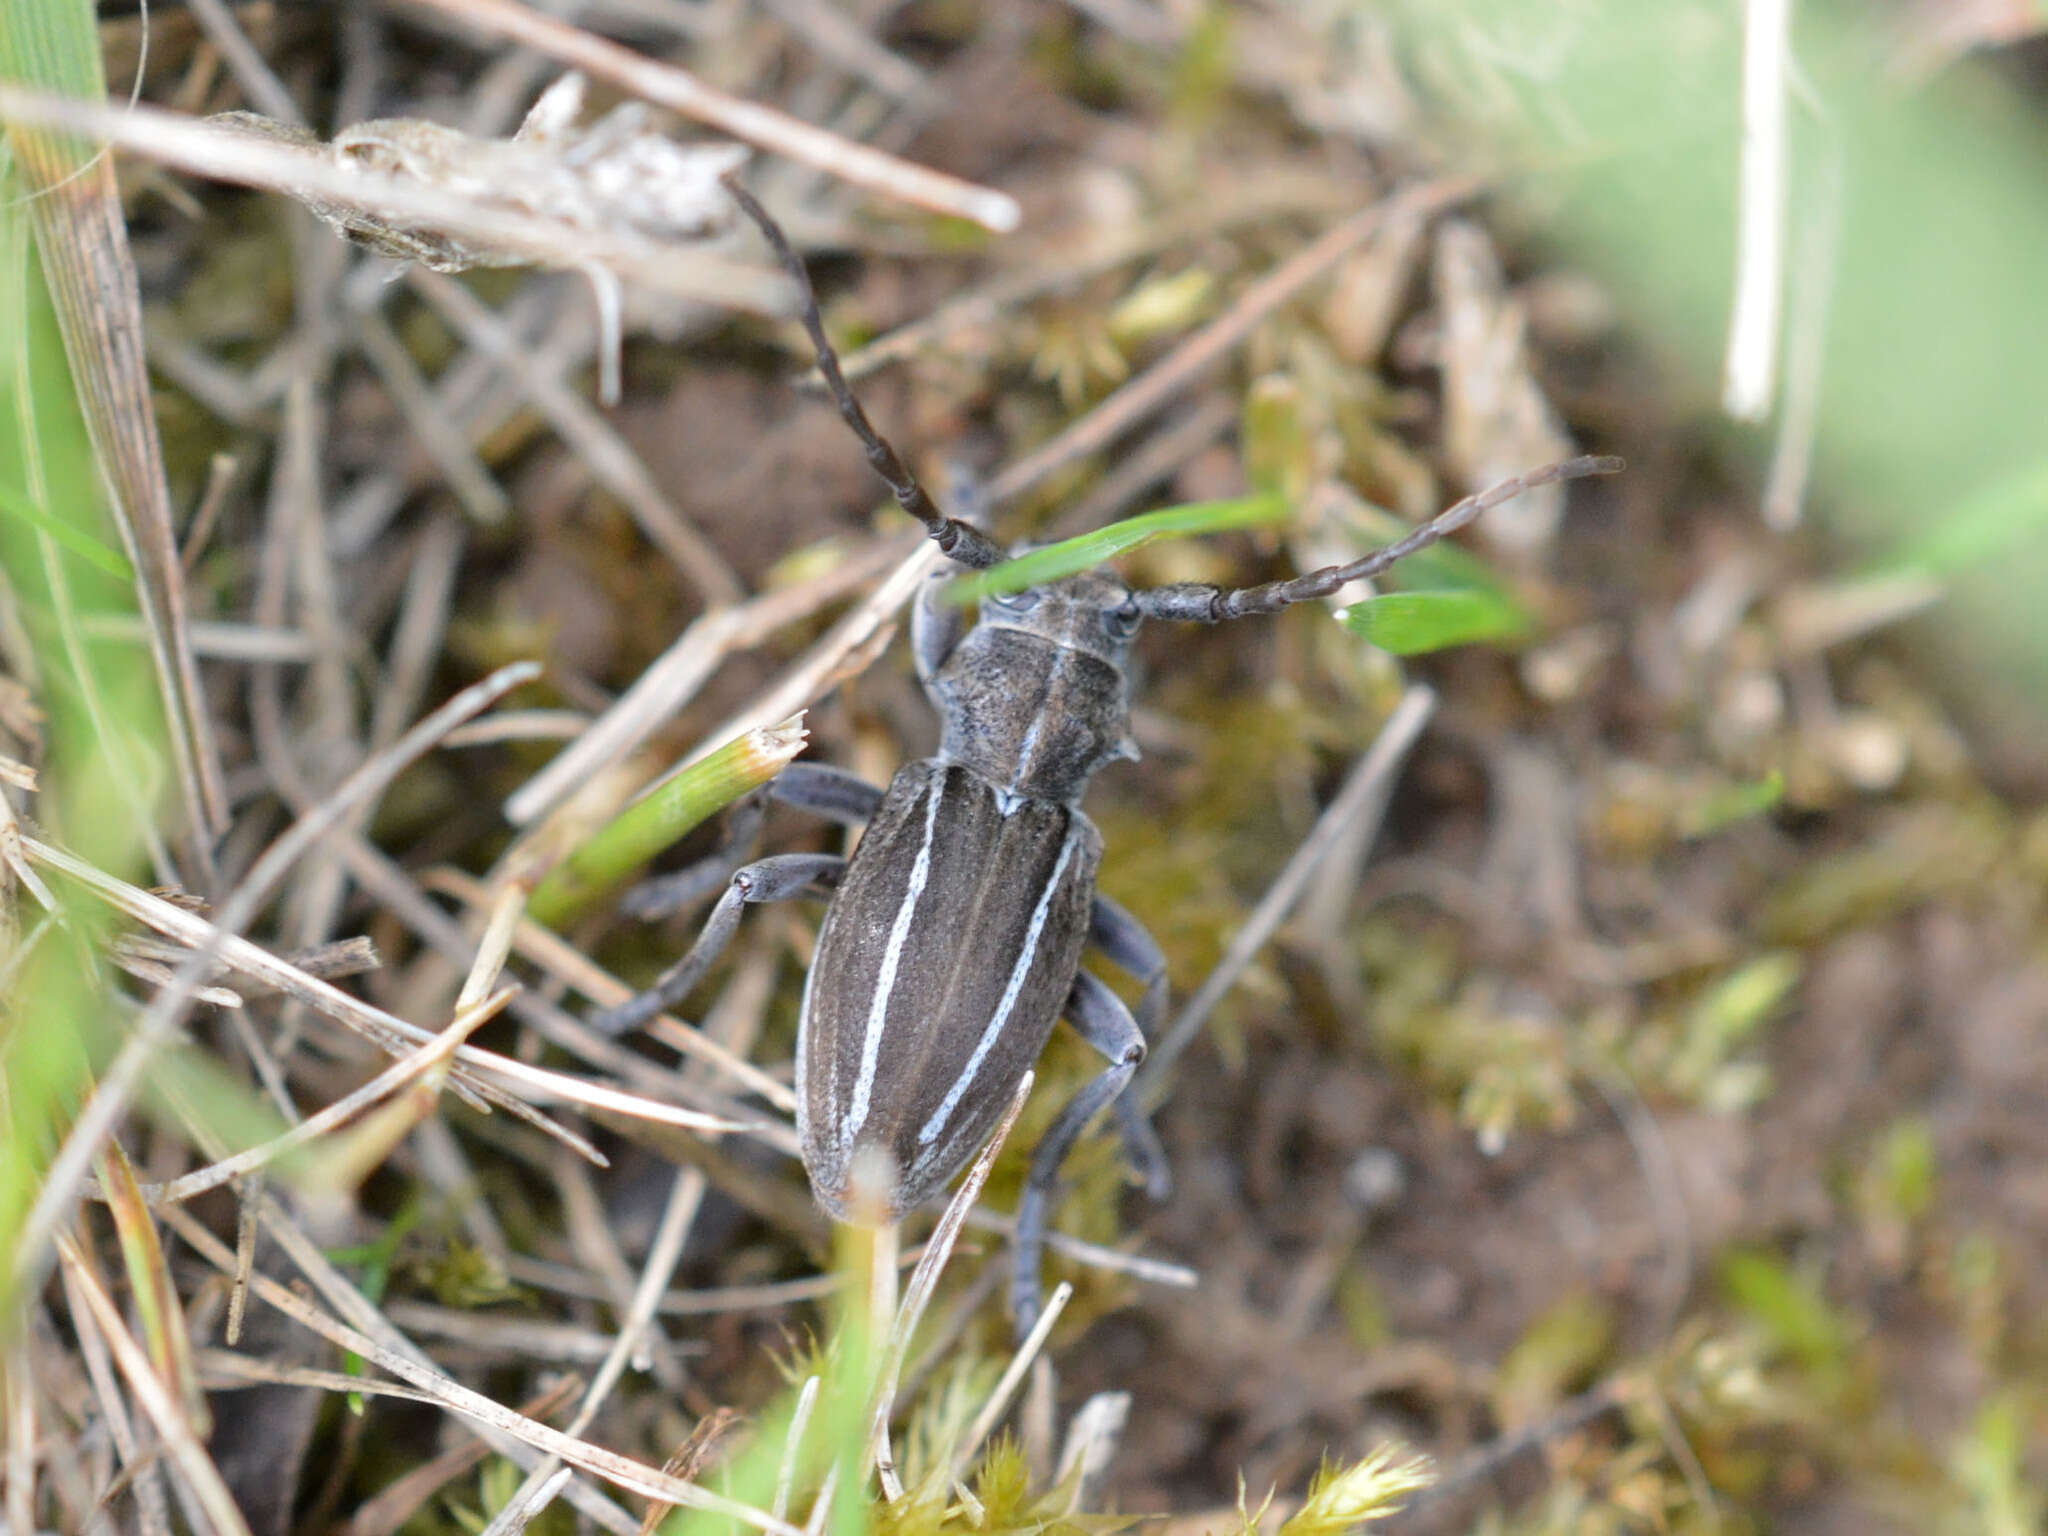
[594,180,1622,1333]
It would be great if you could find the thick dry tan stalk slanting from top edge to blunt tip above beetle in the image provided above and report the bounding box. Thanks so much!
[389,0,1022,233]
